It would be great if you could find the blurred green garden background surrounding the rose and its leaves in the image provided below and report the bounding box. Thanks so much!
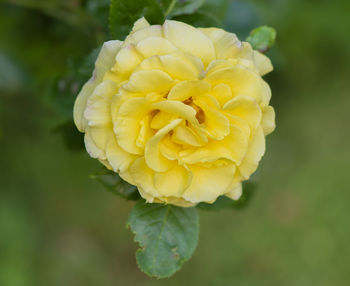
[0,0,350,286]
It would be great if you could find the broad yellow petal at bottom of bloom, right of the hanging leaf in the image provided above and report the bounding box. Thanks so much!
[183,164,236,203]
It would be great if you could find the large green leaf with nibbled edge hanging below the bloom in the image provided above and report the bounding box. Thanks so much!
[127,201,199,278]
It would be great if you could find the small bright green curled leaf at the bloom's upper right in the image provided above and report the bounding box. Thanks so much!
[247,26,277,53]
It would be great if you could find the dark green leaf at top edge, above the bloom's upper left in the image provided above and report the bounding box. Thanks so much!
[109,0,164,40]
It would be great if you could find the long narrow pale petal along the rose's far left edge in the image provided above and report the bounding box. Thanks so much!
[73,41,122,132]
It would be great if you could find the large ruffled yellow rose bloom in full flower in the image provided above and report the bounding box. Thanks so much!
[74,18,275,207]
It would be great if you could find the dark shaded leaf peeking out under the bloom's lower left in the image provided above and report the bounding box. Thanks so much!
[90,169,140,200]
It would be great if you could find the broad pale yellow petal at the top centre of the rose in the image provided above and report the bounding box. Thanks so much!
[163,20,215,65]
